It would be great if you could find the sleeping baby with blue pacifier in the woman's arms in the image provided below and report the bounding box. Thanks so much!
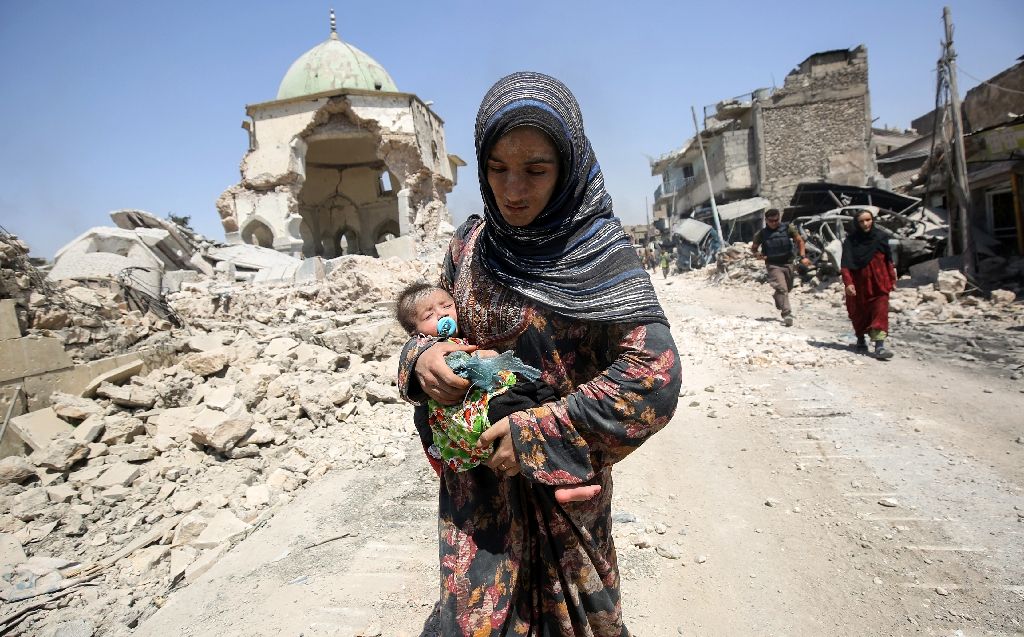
[395,283,601,503]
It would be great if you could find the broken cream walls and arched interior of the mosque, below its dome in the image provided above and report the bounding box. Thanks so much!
[217,91,454,258]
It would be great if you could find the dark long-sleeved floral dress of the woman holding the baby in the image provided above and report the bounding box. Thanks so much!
[398,218,680,637]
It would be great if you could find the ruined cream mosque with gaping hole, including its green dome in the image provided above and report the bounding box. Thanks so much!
[217,10,465,258]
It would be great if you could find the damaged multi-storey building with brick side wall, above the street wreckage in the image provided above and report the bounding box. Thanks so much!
[651,46,876,241]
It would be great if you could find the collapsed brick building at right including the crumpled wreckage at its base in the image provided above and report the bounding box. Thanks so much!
[651,46,946,278]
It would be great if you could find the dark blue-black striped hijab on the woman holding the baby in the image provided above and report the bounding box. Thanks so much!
[476,72,668,325]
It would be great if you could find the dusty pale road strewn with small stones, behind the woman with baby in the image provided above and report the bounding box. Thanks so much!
[133,274,1024,637]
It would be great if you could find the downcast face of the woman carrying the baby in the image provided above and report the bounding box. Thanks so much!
[486,126,558,227]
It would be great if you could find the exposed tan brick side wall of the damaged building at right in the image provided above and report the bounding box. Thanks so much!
[755,46,874,208]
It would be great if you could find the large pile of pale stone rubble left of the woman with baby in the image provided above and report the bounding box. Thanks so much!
[0,256,436,635]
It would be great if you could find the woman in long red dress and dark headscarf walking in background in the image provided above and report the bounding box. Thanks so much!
[841,210,896,360]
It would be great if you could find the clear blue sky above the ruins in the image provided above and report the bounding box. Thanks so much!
[0,0,1024,257]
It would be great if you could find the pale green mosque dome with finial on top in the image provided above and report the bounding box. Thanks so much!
[278,11,398,99]
